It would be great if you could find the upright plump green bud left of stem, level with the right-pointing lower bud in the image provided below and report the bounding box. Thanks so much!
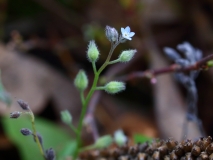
[74,70,88,91]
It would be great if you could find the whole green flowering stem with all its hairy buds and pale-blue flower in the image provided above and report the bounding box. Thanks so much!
[71,26,136,159]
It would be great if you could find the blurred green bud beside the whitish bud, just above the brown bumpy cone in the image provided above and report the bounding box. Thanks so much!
[94,135,113,149]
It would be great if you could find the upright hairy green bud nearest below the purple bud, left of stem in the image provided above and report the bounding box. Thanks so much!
[87,41,100,62]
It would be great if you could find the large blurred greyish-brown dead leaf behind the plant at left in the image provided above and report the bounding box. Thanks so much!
[0,44,80,122]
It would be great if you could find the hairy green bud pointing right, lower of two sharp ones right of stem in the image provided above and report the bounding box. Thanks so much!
[104,81,126,94]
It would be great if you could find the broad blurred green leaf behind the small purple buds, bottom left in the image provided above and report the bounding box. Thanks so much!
[2,116,73,160]
